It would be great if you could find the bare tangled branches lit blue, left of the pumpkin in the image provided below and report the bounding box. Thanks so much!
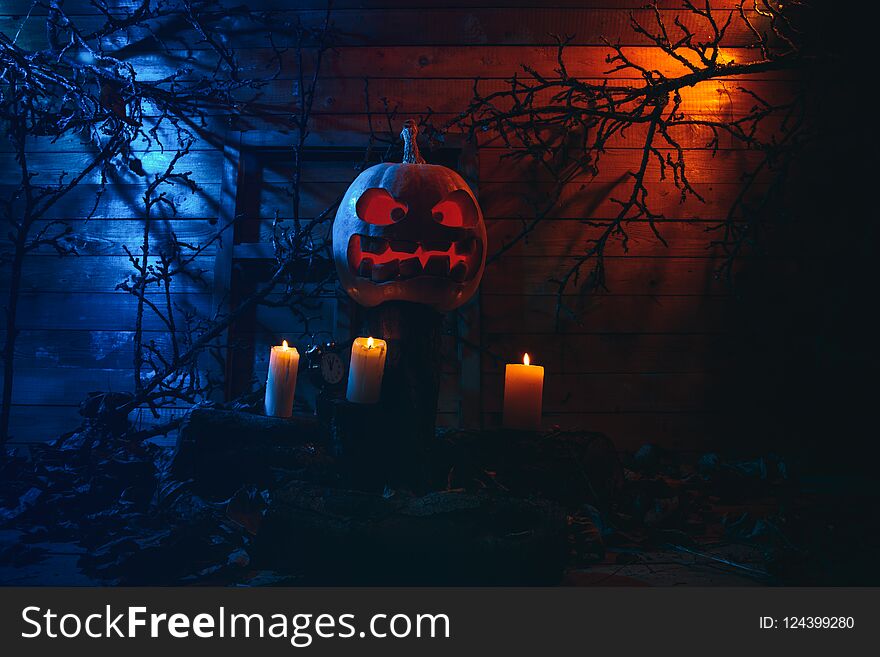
[0,0,348,443]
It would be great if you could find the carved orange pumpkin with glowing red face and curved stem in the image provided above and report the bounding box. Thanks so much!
[333,121,486,311]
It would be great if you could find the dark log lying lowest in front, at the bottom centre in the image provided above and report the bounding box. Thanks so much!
[256,482,567,586]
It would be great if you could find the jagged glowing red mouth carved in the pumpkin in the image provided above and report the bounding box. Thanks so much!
[348,235,483,283]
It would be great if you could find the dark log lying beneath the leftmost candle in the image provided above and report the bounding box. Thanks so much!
[164,409,334,499]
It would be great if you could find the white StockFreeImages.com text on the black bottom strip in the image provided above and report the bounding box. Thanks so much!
[21,605,451,648]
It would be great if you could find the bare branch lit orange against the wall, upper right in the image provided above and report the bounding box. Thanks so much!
[438,0,813,321]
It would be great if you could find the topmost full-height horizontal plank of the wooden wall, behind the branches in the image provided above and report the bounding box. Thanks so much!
[0,7,784,50]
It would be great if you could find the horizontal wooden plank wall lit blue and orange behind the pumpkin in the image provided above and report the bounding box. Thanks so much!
[0,0,793,448]
